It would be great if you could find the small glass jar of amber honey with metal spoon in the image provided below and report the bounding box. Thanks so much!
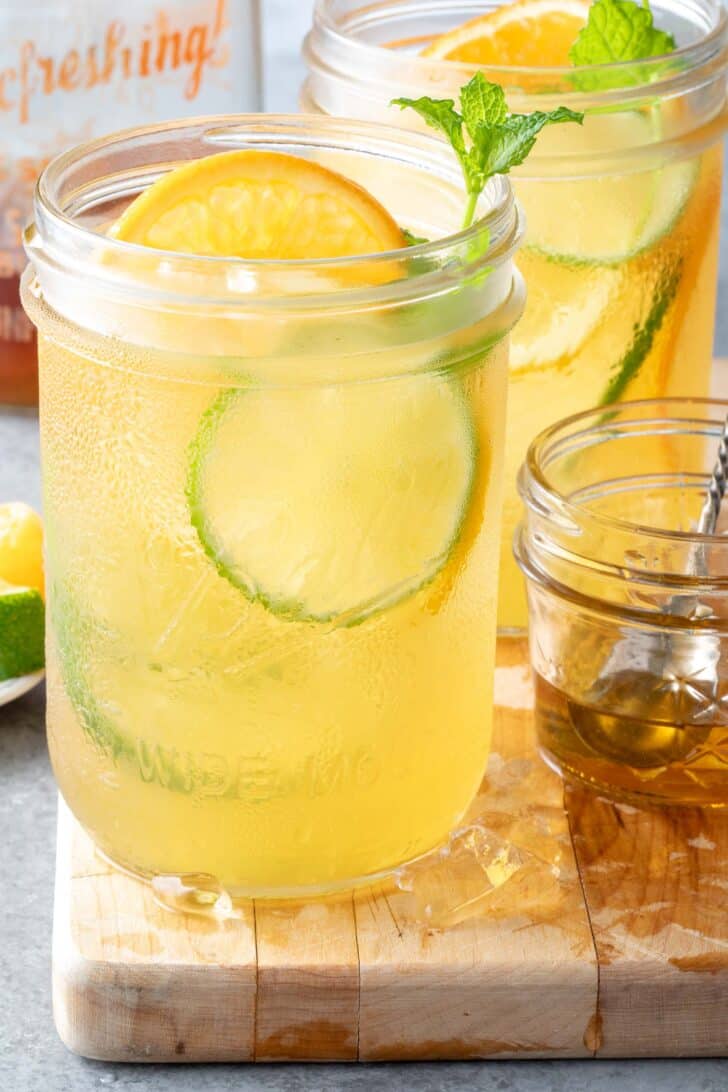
[516,399,728,806]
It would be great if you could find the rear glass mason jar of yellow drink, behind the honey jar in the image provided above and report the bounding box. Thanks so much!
[302,0,728,630]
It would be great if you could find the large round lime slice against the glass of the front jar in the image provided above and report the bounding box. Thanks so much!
[188,376,476,625]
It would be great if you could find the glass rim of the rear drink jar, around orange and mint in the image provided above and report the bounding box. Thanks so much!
[305,0,728,109]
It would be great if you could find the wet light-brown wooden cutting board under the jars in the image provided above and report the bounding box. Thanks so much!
[53,641,728,1061]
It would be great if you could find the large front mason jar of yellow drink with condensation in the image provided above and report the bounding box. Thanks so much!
[24,116,524,897]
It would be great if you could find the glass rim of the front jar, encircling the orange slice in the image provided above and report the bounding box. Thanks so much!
[25,114,523,305]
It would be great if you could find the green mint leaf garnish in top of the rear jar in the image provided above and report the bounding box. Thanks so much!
[569,0,677,91]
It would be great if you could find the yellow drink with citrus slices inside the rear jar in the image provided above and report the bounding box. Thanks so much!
[499,134,723,629]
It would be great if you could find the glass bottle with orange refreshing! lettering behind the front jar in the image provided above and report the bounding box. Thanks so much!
[0,0,260,403]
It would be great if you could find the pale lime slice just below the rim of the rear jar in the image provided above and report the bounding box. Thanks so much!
[517,111,697,265]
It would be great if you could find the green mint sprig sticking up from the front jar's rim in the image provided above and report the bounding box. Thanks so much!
[392,72,584,228]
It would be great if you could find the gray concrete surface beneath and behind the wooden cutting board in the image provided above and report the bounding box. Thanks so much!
[0,0,728,1092]
